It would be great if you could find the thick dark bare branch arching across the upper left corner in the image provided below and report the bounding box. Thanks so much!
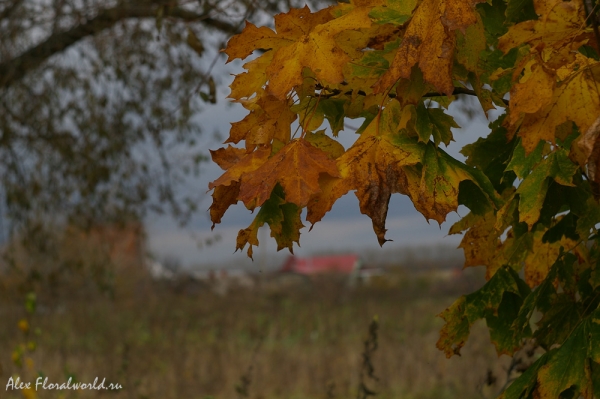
[0,4,239,89]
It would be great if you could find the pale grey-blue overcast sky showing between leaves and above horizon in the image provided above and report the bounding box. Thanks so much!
[147,55,502,267]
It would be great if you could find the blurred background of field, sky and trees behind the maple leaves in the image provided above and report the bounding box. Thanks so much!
[0,0,514,399]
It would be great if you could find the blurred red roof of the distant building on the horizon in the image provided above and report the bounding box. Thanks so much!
[281,254,360,274]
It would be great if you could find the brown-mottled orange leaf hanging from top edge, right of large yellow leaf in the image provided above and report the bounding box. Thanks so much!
[374,0,480,96]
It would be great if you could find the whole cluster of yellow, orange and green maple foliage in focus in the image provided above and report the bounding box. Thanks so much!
[210,0,600,398]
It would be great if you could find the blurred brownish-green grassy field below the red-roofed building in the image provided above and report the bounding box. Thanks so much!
[0,266,509,399]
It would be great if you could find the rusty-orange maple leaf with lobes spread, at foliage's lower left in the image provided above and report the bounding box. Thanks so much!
[239,139,339,209]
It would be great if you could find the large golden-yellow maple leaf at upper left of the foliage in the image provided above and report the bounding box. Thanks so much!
[224,7,371,100]
